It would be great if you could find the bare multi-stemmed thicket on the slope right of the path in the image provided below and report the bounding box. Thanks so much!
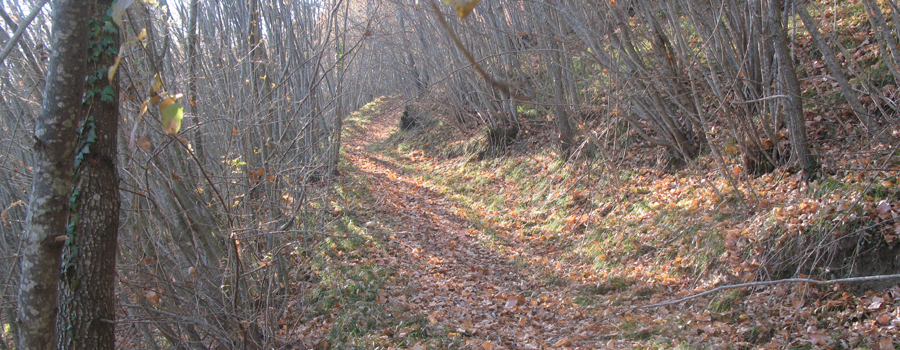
[391,0,900,176]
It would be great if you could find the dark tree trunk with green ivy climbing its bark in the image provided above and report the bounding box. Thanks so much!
[57,0,119,350]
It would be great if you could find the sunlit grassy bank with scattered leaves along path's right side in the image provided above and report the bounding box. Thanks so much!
[368,96,900,348]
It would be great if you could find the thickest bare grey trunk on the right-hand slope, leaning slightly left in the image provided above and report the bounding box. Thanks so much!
[769,0,818,180]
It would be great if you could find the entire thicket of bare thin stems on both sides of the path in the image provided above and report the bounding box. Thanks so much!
[0,0,900,348]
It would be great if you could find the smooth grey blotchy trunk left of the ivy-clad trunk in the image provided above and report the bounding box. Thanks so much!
[17,0,90,349]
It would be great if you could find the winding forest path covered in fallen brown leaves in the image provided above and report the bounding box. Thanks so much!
[345,102,599,350]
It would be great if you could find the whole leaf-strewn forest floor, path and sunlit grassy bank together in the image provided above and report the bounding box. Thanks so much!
[288,99,900,350]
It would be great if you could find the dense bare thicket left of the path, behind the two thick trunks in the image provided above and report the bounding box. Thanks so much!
[0,0,379,349]
